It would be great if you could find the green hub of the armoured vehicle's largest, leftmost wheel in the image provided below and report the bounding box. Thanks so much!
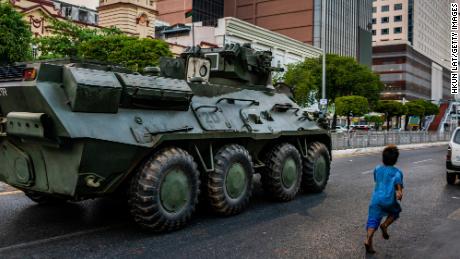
[160,169,190,213]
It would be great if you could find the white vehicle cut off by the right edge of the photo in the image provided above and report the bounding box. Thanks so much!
[446,127,460,184]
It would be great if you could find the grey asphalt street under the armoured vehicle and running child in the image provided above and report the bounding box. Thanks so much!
[0,146,460,258]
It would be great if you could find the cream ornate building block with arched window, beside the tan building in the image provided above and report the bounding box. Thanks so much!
[98,0,158,37]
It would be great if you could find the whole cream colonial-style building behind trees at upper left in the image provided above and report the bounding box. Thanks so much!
[9,0,158,37]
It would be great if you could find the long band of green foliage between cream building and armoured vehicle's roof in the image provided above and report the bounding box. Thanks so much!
[32,19,172,71]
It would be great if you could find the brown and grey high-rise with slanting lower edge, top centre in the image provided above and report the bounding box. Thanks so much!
[224,0,372,65]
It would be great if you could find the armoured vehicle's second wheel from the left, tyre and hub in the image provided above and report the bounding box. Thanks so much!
[207,145,254,216]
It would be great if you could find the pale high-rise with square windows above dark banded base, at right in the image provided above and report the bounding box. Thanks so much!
[372,0,452,101]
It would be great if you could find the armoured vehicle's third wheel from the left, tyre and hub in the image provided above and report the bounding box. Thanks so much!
[262,143,302,201]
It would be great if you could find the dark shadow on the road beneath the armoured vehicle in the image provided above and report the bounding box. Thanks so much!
[0,178,327,249]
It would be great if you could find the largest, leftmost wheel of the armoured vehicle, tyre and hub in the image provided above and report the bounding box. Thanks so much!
[129,147,200,232]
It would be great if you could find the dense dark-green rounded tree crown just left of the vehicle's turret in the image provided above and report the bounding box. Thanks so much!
[78,35,172,71]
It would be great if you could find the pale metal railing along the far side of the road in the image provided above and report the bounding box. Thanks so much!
[331,131,452,150]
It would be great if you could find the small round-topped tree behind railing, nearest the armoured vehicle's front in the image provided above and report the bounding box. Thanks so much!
[335,95,369,128]
